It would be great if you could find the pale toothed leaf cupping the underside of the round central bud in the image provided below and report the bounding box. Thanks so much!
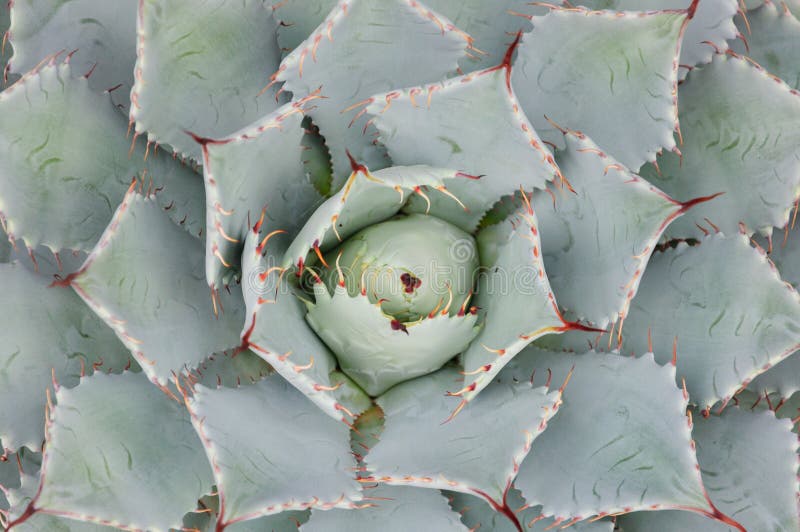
[306,282,478,397]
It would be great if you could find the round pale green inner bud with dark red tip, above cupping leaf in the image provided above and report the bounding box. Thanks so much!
[325,214,478,322]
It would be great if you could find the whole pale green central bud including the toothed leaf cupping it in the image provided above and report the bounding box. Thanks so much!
[306,214,480,396]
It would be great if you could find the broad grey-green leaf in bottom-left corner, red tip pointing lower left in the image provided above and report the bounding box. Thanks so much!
[12,373,213,530]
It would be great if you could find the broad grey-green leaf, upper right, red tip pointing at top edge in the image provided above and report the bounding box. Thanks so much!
[511,8,689,171]
